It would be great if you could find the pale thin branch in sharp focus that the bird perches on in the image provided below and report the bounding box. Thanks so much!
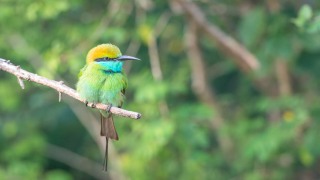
[0,58,141,119]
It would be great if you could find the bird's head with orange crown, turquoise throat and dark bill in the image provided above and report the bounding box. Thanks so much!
[87,44,140,72]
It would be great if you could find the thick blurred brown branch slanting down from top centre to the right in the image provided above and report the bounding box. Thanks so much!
[175,0,260,72]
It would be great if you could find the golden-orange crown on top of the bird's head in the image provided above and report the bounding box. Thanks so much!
[87,44,122,63]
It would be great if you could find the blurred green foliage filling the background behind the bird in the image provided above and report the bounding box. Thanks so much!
[0,0,320,180]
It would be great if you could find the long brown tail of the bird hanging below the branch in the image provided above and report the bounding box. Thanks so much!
[100,113,119,171]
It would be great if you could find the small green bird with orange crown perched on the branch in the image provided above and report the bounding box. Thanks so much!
[76,43,140,171]
